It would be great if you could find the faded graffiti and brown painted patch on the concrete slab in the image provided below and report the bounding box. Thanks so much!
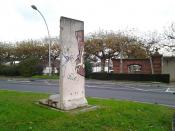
[61,30,85,81]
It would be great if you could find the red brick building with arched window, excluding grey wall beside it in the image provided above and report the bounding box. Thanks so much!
[112,54,162,74]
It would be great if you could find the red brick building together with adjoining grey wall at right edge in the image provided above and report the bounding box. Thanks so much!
[112,53,175,81]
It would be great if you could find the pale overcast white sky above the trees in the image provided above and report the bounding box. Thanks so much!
[0,0,175,41]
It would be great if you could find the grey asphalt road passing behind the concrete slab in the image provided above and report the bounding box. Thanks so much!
[0,79,175,107]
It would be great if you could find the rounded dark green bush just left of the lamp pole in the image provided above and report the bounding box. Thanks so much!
[19,57,43,77]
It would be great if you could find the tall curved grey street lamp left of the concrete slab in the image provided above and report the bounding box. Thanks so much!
[31,5,51,76]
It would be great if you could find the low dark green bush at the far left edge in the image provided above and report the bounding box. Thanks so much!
[0,65,20,76]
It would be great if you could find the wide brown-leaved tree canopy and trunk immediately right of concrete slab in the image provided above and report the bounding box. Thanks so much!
[85,31,145,72]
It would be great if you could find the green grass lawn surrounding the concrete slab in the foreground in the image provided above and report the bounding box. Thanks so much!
[0,90,175,131]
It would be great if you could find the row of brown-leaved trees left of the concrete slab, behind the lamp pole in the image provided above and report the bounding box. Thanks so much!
[0,39,60,75]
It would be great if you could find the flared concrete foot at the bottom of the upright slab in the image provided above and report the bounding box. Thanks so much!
[39,94,88,111]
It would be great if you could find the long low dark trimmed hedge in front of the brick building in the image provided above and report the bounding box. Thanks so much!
[89,72,170,83]
